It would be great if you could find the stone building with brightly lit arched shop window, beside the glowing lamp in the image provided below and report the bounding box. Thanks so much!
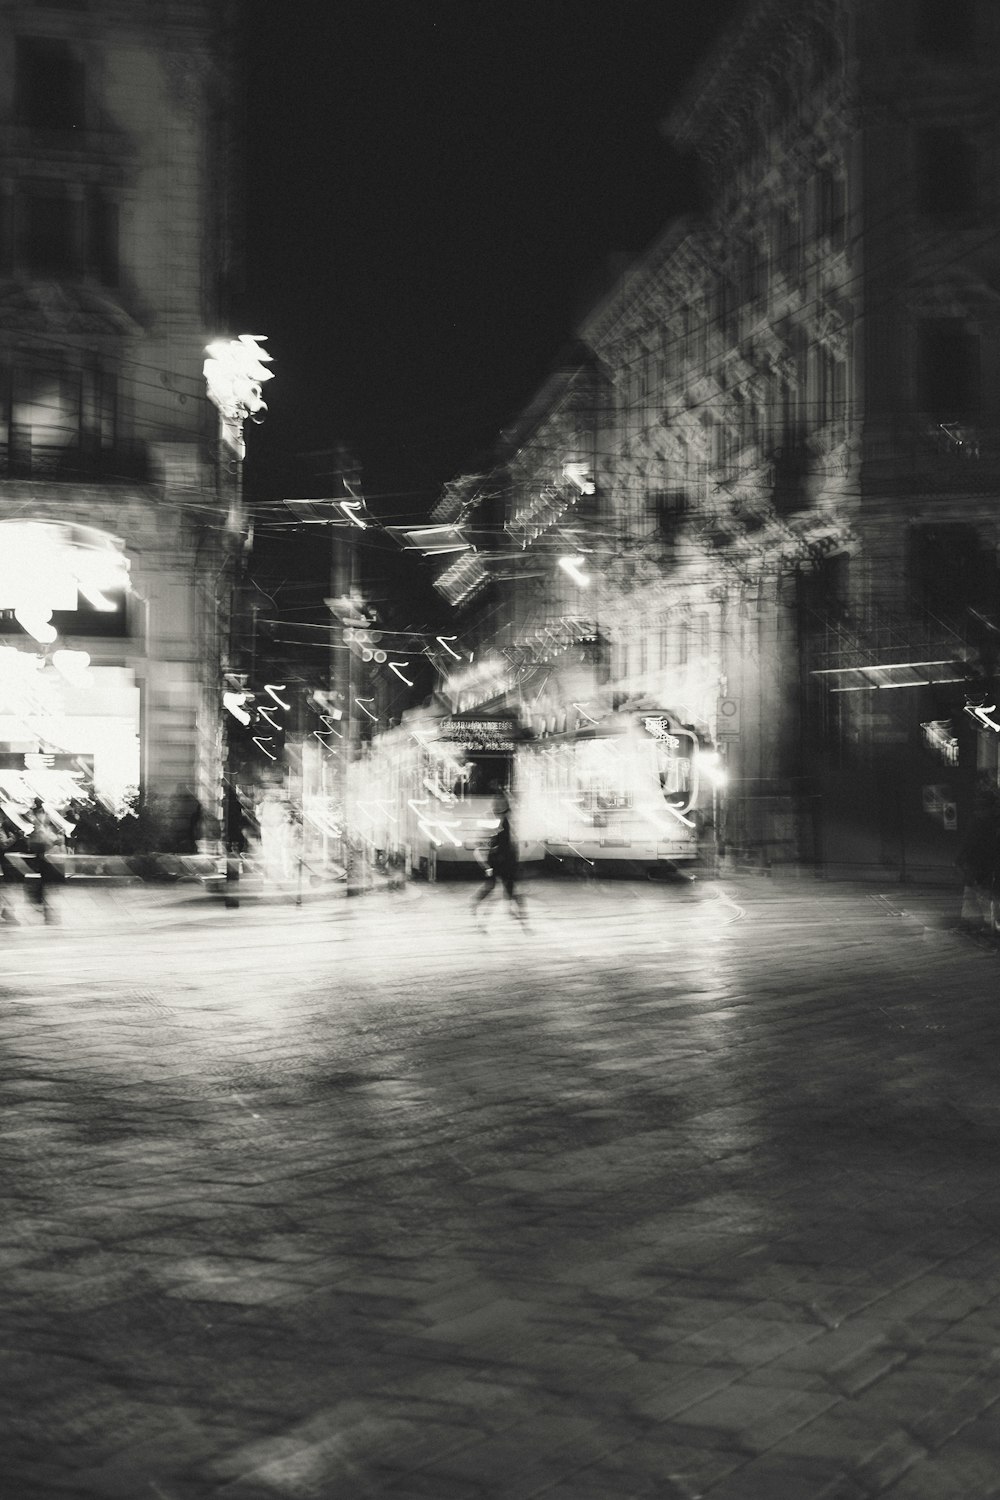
[0,0,240,834]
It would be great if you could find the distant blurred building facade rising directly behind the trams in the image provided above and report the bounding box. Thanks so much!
[432,357,609,737]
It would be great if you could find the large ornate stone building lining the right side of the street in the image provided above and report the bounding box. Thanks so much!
[419,0,1000,878]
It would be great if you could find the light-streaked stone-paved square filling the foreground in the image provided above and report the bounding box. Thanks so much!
[0,879,1000,1500]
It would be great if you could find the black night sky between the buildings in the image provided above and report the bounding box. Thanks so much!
[234,0,739,522]
